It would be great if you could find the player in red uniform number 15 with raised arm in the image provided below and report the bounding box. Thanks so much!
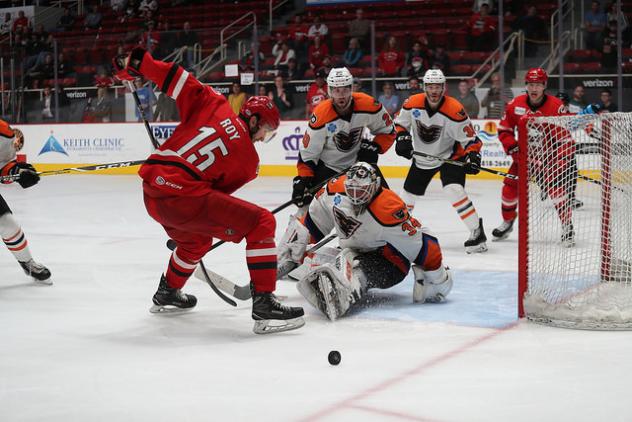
[113,48,304,334]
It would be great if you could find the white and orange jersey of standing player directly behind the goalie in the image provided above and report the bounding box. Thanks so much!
[298,92,395,176]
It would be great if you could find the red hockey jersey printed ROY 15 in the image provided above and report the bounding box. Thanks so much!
[139,53,259,196]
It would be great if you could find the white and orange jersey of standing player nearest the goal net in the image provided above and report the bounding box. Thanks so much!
[395,94,482,169]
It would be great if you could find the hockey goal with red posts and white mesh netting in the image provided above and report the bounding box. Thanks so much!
[518,113,632,330]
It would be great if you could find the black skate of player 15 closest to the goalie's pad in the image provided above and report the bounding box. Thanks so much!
[252,293,305,334]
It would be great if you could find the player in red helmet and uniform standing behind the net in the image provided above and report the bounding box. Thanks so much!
[492,68,575,247]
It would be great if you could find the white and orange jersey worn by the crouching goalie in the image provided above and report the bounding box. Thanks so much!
[303,176,427,262]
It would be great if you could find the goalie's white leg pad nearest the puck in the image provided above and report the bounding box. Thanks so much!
[297,249,366,320]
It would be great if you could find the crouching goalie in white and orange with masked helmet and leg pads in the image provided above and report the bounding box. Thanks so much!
[279,162,452,320]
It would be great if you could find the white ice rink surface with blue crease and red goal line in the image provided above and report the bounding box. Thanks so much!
[0,176,632,422]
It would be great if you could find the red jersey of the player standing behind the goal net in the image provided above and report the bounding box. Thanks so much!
[498,94,566,152]
